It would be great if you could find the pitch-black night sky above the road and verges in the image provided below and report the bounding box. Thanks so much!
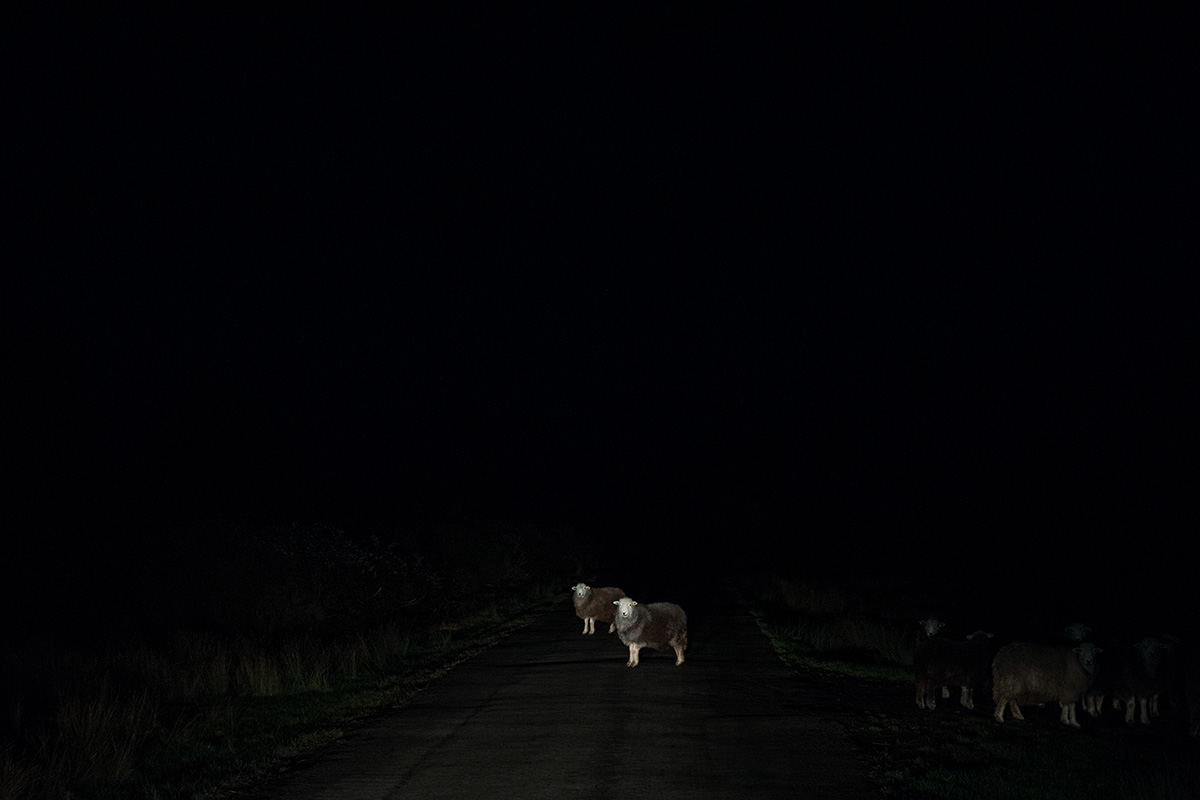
[0,2,1200,606]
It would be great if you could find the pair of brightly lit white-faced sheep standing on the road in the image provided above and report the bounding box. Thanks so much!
[571,583,688,667]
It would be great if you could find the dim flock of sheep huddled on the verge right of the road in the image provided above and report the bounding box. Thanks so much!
[913,618,1200,736]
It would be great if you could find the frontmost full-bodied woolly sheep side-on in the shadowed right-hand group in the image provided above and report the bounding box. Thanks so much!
[991,642,1102,728]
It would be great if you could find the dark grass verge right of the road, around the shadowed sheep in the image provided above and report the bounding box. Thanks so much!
[755,575,1200,800]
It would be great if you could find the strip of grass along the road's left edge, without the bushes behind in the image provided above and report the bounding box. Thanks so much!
[0,587,560,800]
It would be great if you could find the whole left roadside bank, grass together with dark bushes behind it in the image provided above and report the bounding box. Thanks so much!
[0,527,574,800]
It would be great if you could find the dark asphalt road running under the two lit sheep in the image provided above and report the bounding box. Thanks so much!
[258,587,878,800]
